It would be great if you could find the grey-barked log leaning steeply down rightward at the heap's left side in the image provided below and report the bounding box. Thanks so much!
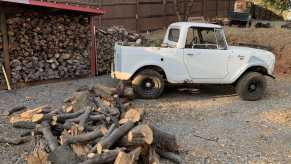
[40,121,59,151]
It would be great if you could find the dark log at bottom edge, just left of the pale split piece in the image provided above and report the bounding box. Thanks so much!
[81,149,121,164]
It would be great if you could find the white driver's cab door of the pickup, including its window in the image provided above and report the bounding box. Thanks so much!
[183,27,231,79]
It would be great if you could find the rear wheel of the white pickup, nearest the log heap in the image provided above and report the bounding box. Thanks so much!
[132,69,165,99]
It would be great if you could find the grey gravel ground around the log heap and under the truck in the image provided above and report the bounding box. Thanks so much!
[0,77,291,164]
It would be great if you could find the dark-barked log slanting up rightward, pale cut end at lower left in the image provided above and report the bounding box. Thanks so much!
[97,122,134,154]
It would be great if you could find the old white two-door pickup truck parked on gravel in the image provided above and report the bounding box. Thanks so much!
[112,22,275,101]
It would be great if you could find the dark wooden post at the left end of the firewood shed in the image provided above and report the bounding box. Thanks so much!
[0,8,11,86]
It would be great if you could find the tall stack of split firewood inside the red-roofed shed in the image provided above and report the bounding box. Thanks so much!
[7,13,90,82]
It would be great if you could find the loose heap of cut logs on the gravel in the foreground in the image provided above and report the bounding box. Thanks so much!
[0,87,183,164]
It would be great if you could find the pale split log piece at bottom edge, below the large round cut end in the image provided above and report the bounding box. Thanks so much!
[114,147,142,164]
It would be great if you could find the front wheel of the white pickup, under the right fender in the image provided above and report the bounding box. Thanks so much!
[236,72,267,101]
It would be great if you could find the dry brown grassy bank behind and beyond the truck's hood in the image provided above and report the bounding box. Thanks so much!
[225,27,291,73]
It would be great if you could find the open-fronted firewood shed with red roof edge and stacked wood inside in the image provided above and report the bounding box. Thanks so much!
[0,0,104,88]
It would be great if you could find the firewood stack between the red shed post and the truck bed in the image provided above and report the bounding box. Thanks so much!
[96,26,143,74]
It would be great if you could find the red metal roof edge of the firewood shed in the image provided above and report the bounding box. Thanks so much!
[0,0,105,15]
